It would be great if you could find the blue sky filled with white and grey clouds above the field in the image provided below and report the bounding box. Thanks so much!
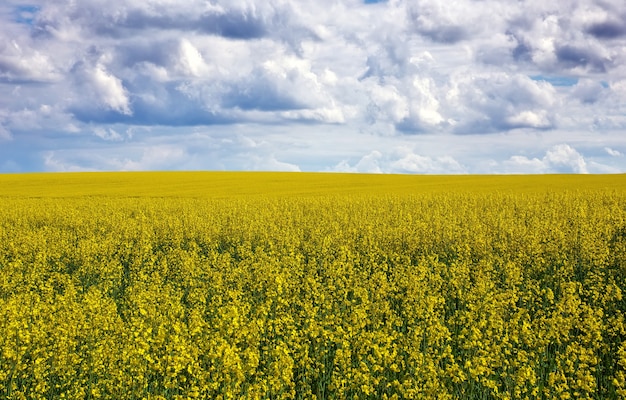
[0,0,626,174]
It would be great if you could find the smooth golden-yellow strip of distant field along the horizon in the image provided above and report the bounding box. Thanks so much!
[0,172,626,198]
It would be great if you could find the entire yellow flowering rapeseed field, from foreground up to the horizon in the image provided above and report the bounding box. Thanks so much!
[0,173,626,399]
